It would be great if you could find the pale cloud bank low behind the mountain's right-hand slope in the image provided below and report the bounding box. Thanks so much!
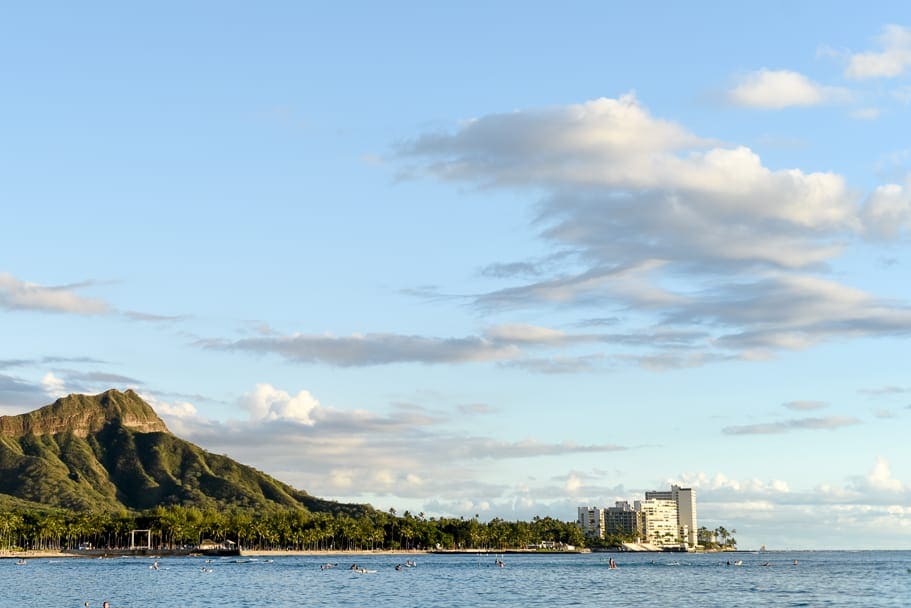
[143,383,627,499]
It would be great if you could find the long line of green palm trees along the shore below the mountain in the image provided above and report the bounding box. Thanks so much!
[0,506,586,551]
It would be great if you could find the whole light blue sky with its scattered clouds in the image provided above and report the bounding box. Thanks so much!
[0,1,911,549]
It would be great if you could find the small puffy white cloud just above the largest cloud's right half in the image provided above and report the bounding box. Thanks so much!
[728,68,850,110]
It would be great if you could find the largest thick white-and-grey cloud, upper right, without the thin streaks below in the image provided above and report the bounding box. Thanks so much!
[402,95,860,272]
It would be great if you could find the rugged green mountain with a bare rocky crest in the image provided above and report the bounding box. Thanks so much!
[0,390,371,515]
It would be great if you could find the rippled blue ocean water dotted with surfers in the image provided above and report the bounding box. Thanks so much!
[0,551,911,608]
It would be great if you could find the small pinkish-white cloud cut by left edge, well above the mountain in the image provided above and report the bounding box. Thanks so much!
[0,272,110,315]
